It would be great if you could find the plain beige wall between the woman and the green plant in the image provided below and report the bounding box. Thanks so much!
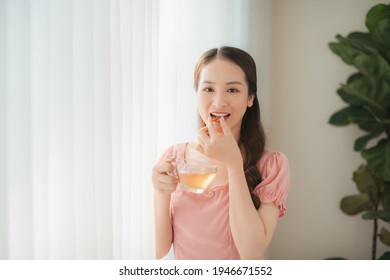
[268,0,388,259]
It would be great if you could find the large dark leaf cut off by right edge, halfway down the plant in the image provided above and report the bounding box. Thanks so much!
[361,139,390,181]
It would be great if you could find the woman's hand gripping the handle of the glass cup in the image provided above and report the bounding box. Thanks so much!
[152,159,179,195]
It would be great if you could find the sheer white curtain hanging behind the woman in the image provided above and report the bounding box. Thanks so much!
[0,0,268,259]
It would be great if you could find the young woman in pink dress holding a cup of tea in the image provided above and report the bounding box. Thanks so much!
[152,47,290,259]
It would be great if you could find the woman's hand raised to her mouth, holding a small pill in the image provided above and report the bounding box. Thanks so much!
[197,118,242,166]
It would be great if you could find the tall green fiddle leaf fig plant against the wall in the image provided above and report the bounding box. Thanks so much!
[329,4,390,259]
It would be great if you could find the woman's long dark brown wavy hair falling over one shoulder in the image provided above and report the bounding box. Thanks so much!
[194,46,265,209]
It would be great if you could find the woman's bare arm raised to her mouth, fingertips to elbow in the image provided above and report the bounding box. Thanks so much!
[198,118,279,259]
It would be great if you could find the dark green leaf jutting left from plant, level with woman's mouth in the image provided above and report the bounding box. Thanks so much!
[329,107,375,126]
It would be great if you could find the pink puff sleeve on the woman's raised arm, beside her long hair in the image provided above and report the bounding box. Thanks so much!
[253,151,290,217]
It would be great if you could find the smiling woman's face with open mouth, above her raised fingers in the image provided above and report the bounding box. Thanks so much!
[197,58,253,140]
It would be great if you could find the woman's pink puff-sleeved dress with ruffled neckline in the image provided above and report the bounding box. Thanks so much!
[158,144,290,260]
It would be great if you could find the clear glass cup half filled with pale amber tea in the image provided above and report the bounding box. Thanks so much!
[175,159,218,193]
